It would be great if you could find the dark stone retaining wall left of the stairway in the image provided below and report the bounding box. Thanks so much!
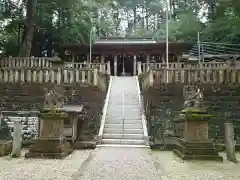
[0,83,106,143]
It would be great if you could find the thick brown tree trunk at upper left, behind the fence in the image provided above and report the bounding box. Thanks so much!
[19,0,36,57]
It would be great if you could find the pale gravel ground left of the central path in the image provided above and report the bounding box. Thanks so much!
[0,150,91,180]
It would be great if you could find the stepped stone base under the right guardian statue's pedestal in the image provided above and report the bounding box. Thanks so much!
[173,139,223,161]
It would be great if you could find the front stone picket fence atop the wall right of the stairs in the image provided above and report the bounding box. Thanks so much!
[141,67,240,88]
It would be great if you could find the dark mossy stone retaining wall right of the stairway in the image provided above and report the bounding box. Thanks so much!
[142,84,240,143]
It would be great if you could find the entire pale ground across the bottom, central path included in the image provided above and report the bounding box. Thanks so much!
[0,147,240,180]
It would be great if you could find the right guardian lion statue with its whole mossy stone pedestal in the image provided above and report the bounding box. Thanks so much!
[174,86,223,161]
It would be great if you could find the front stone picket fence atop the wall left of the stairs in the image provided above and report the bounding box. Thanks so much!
[0,67,107,89]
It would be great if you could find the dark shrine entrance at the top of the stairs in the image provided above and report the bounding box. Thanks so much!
[117,54,134,76]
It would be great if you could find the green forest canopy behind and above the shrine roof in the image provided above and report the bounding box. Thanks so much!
[0,0,240,57]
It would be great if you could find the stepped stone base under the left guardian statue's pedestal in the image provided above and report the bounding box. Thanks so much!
[25,138,73,159]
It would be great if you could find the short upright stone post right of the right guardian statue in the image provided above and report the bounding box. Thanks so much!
[224,120,237,163]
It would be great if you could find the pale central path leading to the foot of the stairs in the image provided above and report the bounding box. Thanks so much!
[74,147,161,180]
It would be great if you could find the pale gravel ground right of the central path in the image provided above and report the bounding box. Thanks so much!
[151,151,240,180]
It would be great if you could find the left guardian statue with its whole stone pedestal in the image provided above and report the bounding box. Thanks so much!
[25,88,73,158]
